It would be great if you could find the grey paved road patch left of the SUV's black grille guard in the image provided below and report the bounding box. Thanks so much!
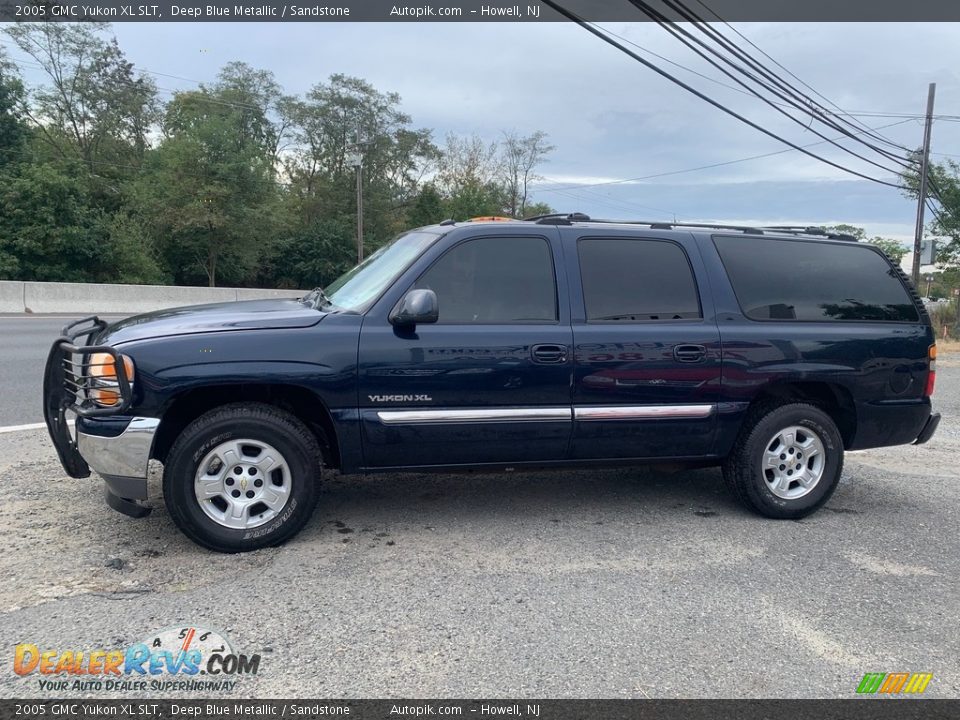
[0,315,126,427]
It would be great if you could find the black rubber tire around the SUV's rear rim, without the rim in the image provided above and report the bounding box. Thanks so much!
[723,403,843,520]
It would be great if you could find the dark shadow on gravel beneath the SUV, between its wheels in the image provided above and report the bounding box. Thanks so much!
[305,466,746,535]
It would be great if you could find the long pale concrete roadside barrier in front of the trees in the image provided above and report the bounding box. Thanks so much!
[0,281,306,315]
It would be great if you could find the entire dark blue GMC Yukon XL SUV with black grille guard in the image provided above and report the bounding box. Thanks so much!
[44,214,940,552]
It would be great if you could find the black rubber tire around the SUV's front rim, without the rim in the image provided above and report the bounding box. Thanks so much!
[163,403,323,553]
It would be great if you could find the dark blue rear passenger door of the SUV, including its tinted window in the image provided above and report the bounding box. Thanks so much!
[561,227,721,458]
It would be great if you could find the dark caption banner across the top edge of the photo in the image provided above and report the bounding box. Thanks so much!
[0,0,960,22]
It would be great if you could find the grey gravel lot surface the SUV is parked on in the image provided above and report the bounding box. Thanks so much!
[0,366,960,698]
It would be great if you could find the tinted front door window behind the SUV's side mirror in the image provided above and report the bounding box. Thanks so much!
[416,237,557,324]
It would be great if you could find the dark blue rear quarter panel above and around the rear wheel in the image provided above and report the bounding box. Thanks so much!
[697,234,934,455]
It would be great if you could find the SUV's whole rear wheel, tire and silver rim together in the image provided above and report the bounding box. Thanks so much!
[723,403,843,519]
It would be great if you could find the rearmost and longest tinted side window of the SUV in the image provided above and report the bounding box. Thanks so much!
[713,237,919,322]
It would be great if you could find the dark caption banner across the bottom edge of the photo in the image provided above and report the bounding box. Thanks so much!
[0,698,960,720]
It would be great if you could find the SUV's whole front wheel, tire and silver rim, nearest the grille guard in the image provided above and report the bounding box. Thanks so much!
[163,403,323,552]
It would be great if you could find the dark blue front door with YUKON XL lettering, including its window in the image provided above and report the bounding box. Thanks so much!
[359,231,573,468]
